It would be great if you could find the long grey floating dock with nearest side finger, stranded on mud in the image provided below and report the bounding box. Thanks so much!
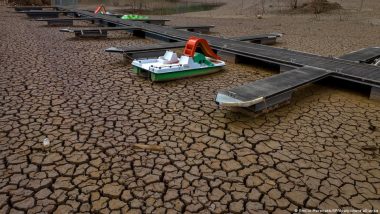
[20,7,380,111]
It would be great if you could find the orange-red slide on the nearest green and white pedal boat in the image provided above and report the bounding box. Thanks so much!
[183,36,221,59]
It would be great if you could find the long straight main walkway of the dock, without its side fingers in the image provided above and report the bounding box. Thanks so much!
[61,10,380,81]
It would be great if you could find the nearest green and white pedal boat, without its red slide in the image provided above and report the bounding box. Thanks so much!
[132,50,225,82]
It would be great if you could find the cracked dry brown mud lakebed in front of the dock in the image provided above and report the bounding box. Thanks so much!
[0,7,380,213]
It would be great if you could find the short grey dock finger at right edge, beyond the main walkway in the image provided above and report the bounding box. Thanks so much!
[339,47,380,63]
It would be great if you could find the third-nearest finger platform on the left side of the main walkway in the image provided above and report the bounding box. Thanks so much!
[59,27,141,38]
